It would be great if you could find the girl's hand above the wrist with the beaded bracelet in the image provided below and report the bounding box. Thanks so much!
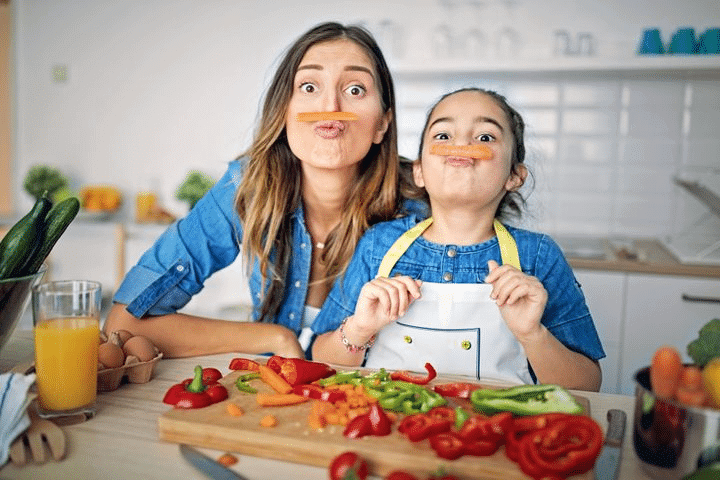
[346,276,422,338]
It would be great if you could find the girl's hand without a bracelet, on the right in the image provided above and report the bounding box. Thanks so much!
[485,260,547,343]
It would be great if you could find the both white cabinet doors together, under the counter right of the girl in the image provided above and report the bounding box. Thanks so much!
[575,269,720,395]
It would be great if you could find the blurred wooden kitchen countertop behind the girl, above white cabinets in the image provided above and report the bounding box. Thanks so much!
[556,237,720,278]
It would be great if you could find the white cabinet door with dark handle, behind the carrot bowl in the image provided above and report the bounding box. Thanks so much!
[618,274,720,394]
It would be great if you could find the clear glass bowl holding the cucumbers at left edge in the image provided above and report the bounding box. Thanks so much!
[0,265,47,350]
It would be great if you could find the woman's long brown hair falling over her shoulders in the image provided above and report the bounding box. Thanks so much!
[235,22,400,321]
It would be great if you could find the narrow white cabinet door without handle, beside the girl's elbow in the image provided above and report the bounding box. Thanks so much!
[575,270,627,393]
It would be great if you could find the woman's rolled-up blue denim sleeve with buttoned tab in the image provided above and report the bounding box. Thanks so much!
[113,160,242,318]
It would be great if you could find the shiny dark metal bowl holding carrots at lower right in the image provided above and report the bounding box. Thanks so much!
[633,367,720,479]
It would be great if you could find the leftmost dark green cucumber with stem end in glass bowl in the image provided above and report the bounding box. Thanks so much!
[0,195,52,279]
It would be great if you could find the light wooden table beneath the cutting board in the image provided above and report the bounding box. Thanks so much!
[0,331,650,480]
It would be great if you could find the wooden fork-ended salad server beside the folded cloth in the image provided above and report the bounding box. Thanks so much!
[10,407,65,466]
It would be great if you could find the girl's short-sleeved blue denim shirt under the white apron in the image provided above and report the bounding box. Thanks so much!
[313,214,605,360]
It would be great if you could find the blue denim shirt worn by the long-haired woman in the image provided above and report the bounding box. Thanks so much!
[113,159,423,334]
